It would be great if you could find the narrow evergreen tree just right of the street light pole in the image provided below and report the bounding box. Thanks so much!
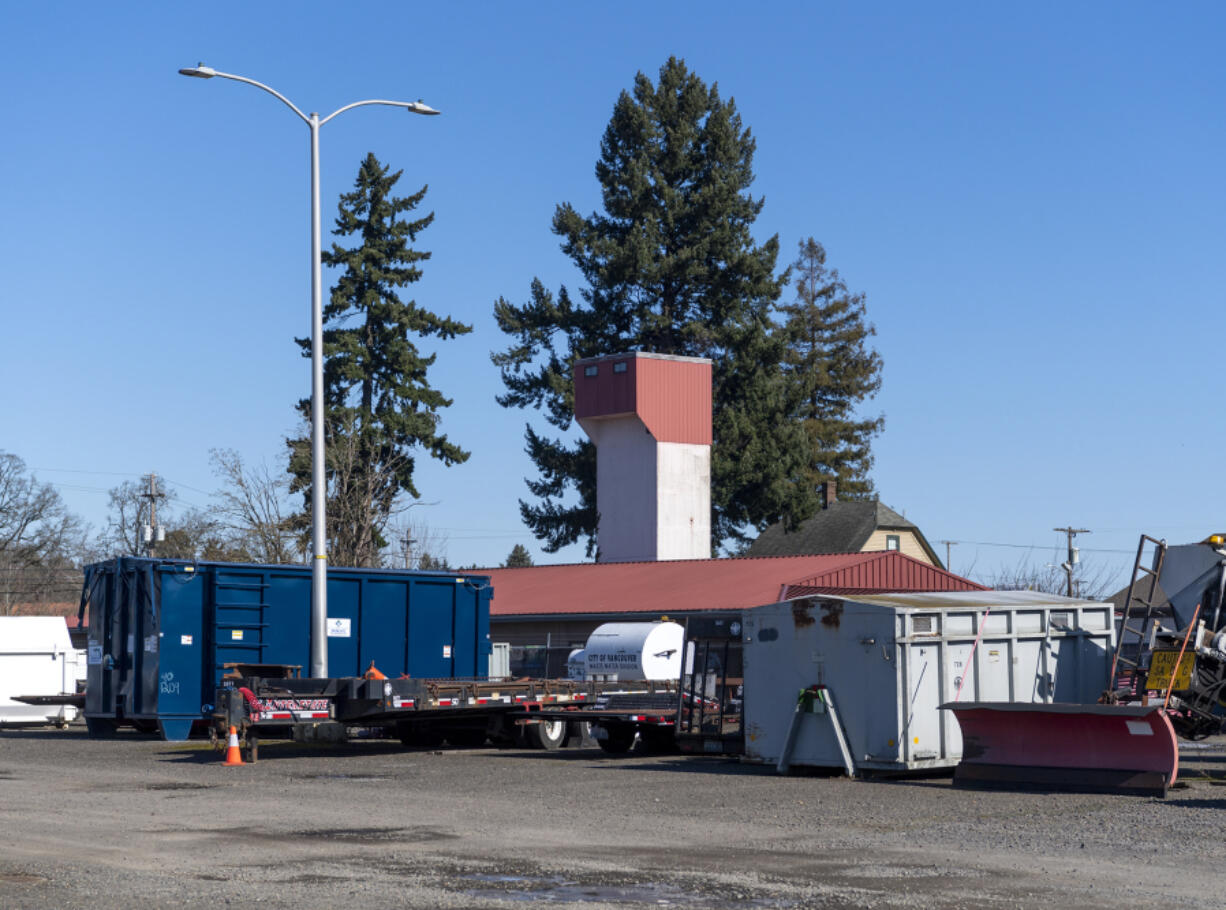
[289,153,472,567]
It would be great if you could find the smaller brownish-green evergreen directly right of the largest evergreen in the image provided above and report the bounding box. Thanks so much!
[780,237,885,497]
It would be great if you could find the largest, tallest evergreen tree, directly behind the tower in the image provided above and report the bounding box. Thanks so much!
[493,58,817,553]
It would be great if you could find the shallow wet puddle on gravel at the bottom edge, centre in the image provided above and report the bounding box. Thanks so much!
[460,874,792,908]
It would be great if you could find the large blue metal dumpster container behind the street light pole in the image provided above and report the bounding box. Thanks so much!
[81,557,493,740]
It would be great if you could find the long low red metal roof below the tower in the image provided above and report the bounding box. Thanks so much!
[482,551,984,617]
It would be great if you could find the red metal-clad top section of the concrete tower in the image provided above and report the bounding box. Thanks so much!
[575,351,711,445]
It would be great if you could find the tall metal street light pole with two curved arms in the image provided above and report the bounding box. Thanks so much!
[179,64,440,678]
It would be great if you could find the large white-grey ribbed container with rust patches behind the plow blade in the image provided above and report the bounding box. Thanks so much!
[743,591,1116,770]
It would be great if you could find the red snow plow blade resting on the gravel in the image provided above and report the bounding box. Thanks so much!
[942,702,1179,796]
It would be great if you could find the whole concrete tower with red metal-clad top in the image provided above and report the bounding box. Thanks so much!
[575,353,711,563]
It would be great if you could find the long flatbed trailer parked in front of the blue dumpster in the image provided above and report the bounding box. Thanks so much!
[210,676,679,760]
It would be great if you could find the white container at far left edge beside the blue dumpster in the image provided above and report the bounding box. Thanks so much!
[0,616,86,725]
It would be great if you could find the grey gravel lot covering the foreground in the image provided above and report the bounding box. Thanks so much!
[0,727,1226,910]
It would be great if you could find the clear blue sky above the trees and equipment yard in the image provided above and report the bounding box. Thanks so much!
[0,2,1226,588]
